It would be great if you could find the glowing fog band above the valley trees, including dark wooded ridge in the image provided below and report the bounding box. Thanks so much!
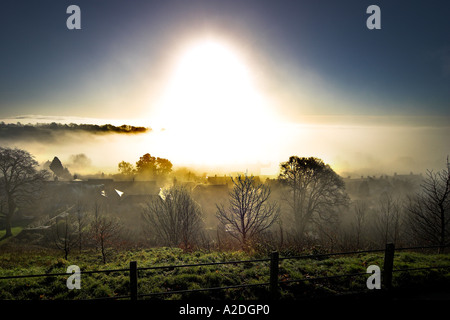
[0,117,450,178]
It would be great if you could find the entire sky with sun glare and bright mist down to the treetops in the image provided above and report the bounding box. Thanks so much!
[0,0,450,175]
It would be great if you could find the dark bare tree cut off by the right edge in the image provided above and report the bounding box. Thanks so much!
[406,157,450,252]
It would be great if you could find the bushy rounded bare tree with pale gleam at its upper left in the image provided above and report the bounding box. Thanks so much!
[143,185,204,248]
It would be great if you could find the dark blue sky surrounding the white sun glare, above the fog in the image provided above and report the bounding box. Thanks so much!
[0,0,450,118]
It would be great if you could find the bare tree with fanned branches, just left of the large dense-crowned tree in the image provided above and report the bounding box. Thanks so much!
[217,175,279,249]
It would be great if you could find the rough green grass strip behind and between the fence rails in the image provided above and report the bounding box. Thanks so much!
[0,248,450,300]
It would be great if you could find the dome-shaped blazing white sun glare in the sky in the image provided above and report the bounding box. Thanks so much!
[153,40,284,170]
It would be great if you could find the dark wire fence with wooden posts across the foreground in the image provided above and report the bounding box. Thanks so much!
[0,243,450,300]
